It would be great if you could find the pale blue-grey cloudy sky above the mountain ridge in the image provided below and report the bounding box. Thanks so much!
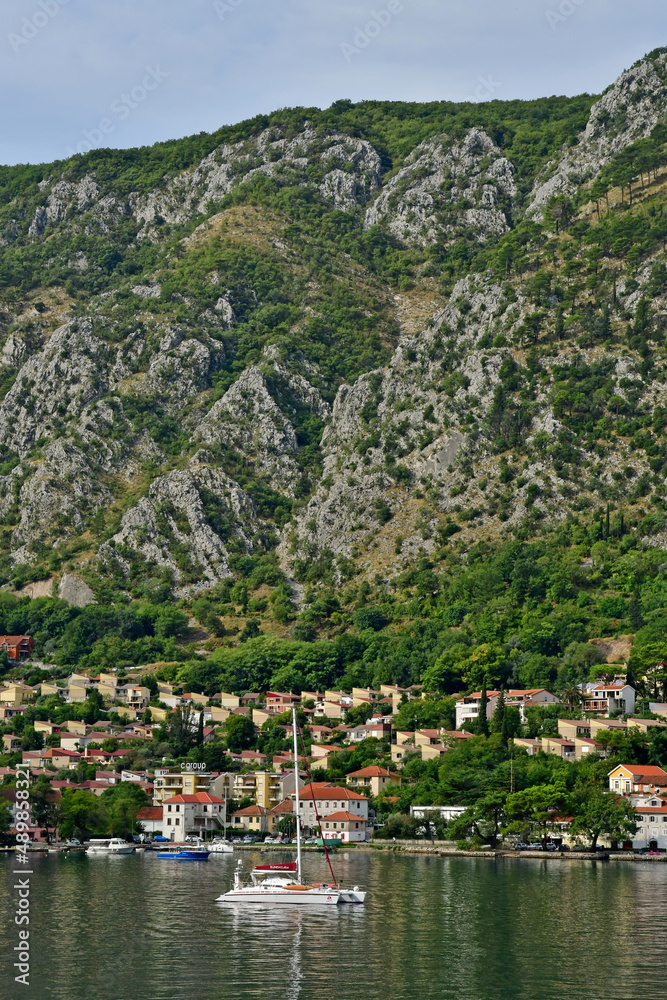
[0,0,667,164]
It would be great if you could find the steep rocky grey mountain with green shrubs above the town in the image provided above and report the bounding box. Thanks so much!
[0,49,667,696]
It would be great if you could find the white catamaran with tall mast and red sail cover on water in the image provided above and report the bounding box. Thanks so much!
[216,707,366,906]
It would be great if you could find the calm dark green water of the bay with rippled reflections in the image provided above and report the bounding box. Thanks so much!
[0,852,667,1000]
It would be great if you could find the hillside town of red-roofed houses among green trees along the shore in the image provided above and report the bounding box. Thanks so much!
[0,635,667,858]
